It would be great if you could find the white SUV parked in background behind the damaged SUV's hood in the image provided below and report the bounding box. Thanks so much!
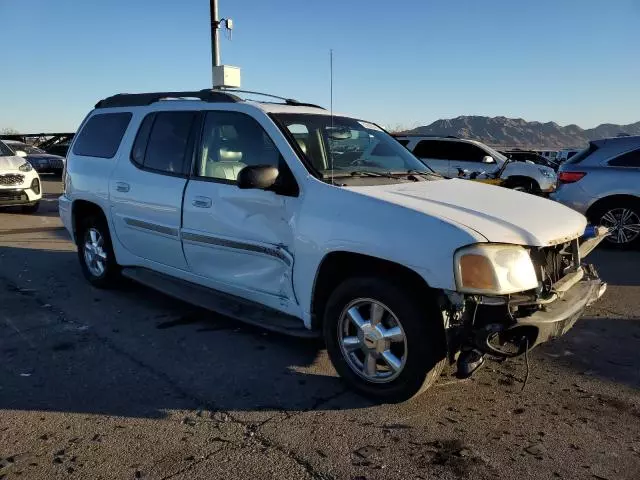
[396,135,557,194]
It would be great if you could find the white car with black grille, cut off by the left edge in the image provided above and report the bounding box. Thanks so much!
[0,141,42,213]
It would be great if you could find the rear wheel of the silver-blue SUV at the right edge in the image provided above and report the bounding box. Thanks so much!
[589,200,640,249]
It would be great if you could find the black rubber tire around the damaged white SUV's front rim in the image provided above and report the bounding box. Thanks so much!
[323,277,447,402]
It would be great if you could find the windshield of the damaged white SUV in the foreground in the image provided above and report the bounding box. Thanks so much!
[273,113,434,178]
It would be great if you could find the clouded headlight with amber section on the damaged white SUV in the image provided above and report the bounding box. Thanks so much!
[454,244,538,295]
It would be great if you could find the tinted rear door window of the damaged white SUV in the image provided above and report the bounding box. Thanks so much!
[131,112,197,175]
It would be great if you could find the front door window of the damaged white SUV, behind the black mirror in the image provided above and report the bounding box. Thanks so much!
[196,111,280,183]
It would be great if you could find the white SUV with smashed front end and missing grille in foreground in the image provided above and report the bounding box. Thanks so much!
[59,90,605,401]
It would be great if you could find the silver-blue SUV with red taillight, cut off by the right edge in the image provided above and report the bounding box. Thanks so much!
[553,136,640,248]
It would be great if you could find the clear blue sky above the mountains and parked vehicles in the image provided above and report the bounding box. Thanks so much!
[0,0,640,131]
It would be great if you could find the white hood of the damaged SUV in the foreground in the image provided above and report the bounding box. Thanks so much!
[347,179,587,247]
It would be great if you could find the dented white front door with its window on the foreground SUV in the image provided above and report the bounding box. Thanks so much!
[181,111,299,309]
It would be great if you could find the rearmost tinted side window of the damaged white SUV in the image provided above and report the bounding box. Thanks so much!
[73,112,131,158]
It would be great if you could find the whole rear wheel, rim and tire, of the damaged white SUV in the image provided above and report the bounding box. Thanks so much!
[77,216,120,288]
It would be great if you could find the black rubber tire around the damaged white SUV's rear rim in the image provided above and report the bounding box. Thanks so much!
[76,216,120,289]
